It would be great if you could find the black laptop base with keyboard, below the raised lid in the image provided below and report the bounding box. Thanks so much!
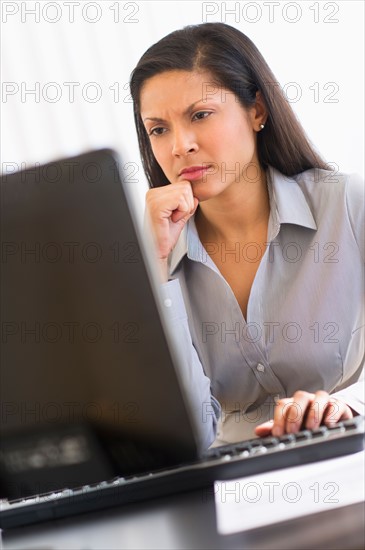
[0,416,365,529]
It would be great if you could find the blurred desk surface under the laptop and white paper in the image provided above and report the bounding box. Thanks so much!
[2,490,365,550]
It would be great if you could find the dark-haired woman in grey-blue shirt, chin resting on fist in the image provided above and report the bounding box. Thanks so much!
[131,23,364,445]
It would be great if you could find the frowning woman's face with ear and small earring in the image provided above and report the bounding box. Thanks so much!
[141,70,263,201]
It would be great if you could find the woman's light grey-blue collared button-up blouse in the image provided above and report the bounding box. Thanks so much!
[158,168,365,445]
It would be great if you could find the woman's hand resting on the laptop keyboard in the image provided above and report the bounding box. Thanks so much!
[255,391,353,437]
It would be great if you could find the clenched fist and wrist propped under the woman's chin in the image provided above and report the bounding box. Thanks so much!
[146,180,198,281]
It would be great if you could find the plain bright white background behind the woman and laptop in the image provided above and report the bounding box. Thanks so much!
[0,0,364,217]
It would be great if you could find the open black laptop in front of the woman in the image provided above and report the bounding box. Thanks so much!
[0,149,364,528]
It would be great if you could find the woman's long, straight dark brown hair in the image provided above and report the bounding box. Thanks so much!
[130,23,330,187]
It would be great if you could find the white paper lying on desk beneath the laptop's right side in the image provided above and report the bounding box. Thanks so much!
[214,451,365,535]
